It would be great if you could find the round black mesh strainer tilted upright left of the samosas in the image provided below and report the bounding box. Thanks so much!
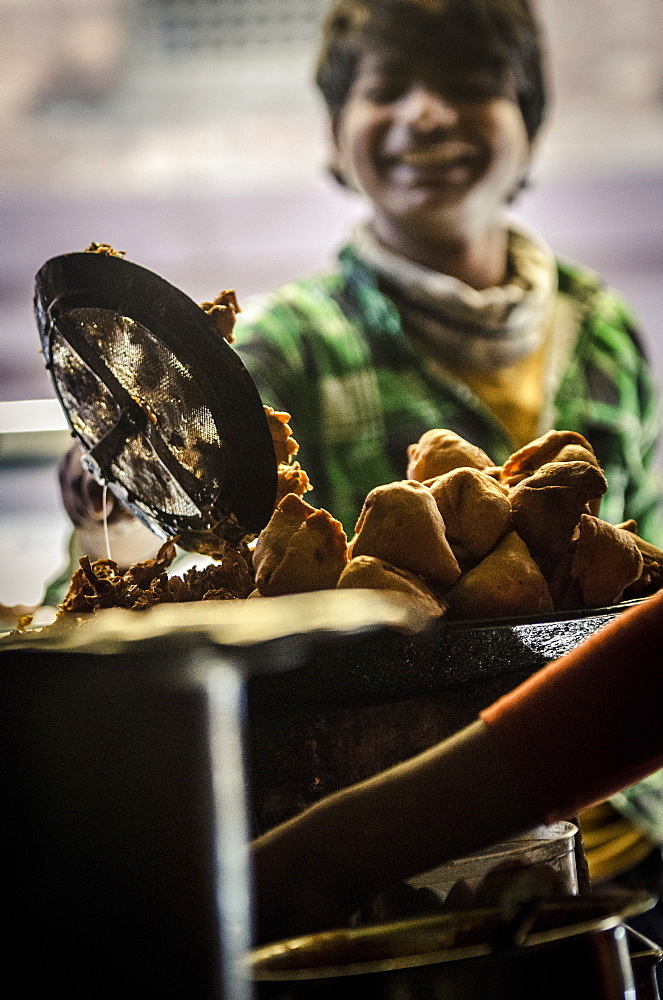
[35,252,276,551]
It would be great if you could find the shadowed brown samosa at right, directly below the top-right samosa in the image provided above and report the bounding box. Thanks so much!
[509,462,608,577]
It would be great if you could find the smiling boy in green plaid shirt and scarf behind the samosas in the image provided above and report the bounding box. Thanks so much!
[235,0,663,544]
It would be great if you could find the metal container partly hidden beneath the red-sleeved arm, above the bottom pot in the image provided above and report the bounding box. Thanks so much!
[408,823,578,906]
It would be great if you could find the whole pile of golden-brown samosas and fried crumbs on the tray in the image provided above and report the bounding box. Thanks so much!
[61,416,663,619]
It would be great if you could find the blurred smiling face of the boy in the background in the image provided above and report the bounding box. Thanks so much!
[334,51,531,254]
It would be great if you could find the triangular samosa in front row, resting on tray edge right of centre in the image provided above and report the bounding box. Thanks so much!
[445,531,553,618]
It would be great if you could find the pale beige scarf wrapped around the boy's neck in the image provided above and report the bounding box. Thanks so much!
[352,221,557,371]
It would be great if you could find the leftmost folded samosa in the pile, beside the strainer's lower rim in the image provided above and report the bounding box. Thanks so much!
[253,493,348,597]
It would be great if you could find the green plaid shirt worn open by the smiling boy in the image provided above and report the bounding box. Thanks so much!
[235,246,663,545]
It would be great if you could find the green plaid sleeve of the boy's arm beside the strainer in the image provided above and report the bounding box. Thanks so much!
[235,274,394,532]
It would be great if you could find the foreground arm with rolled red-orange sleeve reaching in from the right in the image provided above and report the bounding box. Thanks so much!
[252,591,663,940]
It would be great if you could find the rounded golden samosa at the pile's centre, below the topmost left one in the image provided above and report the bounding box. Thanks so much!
[426,468,511,566]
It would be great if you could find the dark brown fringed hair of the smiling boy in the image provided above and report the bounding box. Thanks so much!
[315,0,546,140]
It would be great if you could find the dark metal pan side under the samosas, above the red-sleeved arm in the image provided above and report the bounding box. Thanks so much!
[247,595,640,833]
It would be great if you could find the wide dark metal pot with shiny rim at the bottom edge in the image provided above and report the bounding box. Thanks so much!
[247,893,654,1000]
